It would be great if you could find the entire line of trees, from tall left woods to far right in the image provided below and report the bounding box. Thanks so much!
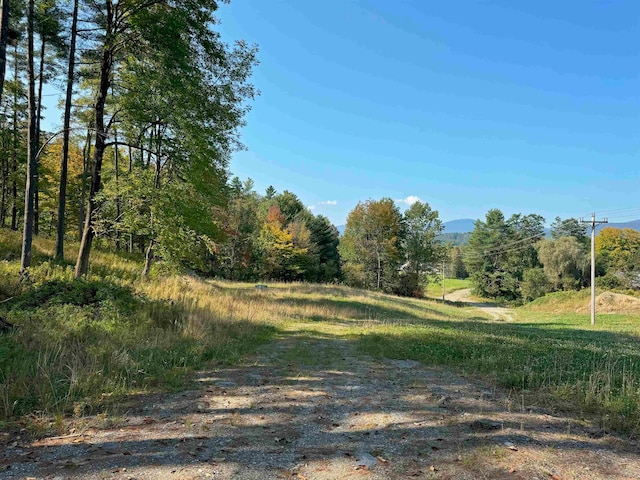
[0,0,640,299]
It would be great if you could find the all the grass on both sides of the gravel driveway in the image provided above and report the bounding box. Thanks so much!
[0,232,640,436]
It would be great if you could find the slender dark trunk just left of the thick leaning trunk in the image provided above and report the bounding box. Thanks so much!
[56,0,78,260]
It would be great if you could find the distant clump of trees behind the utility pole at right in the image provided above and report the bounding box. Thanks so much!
[462,209,640,301]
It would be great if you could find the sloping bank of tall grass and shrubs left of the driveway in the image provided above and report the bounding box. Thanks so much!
[0,231,276,420]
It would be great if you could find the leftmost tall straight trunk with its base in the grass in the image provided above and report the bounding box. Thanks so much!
[20,0,38,272]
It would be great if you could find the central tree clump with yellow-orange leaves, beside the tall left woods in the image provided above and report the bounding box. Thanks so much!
[209,178,341,282]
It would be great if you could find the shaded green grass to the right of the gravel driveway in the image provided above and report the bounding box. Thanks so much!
[360,309,640,436]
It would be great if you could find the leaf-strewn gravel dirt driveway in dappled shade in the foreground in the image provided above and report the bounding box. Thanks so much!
[0,322,640,480]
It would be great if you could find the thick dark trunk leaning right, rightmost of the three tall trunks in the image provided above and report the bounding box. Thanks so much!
[74,0,114,278]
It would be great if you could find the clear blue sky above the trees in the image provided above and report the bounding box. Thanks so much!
[219,0,640,224]
